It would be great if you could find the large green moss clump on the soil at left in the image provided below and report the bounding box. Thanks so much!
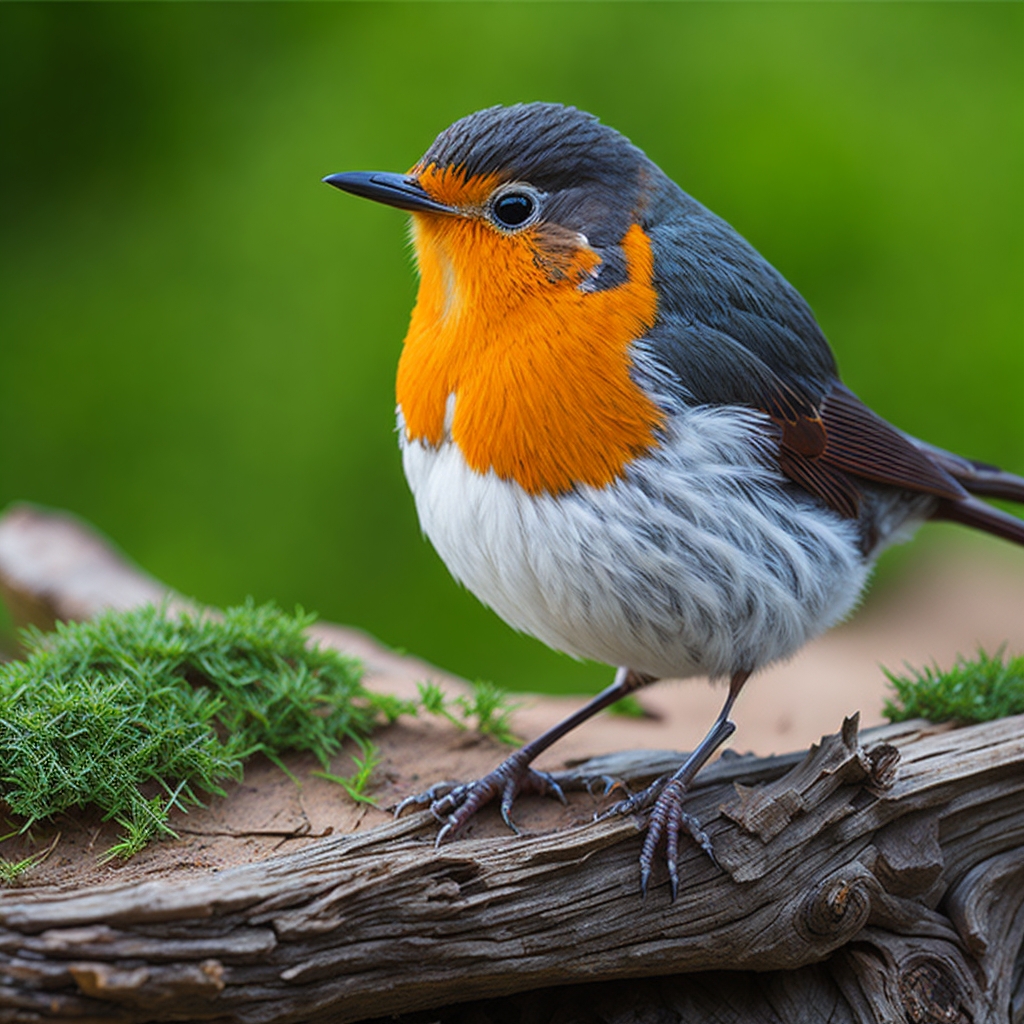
[0,602,387,857]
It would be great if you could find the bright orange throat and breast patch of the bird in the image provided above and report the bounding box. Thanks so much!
[397,216,664,495]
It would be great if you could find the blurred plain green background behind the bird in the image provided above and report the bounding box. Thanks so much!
[0,3,1024,690]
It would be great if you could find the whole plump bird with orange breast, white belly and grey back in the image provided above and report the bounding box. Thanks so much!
[323,102,1024,899]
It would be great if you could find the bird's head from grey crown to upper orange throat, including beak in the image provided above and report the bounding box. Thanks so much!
[325,103,662,315]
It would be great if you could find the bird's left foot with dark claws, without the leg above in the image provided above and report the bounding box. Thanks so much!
[394,751,565,846]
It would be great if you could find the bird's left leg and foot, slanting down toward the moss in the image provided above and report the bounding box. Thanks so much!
[395,668,654,846]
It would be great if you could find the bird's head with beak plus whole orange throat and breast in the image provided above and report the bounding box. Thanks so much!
[325,103,674,493]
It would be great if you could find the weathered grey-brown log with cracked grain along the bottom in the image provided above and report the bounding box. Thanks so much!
[0,505,1024,1024]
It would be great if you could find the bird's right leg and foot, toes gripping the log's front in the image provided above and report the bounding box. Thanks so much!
[609,672,751,900]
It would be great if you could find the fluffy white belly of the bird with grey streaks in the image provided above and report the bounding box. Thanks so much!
[399,407,869,678]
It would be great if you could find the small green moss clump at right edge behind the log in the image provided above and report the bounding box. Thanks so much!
[883,650,1024,722]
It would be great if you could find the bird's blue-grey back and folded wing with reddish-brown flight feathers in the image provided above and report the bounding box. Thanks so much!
[637,194,962,517]
